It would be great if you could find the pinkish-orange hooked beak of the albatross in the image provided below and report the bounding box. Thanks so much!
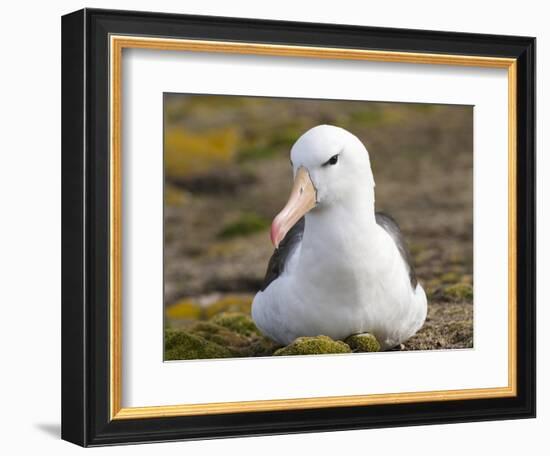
[271,166,317,249]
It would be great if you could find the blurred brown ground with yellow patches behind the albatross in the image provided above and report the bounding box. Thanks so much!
[164,94,473,358]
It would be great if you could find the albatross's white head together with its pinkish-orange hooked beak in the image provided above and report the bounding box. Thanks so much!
[271,125,374,247]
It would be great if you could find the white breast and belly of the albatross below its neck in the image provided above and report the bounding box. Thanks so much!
[252,222,427,349]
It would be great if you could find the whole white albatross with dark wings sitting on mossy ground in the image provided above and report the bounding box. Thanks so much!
[252,125,427,350]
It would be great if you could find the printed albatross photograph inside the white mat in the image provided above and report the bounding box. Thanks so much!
[163,93,474,361]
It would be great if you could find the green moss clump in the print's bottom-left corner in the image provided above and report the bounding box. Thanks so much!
[164,330,234,361]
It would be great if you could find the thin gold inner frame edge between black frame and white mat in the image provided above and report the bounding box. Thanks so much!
[109,35,517,420]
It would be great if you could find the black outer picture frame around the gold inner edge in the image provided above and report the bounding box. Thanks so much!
[62,9,536,446]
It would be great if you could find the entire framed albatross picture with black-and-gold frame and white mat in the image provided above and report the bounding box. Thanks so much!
[62,9,535,446]
